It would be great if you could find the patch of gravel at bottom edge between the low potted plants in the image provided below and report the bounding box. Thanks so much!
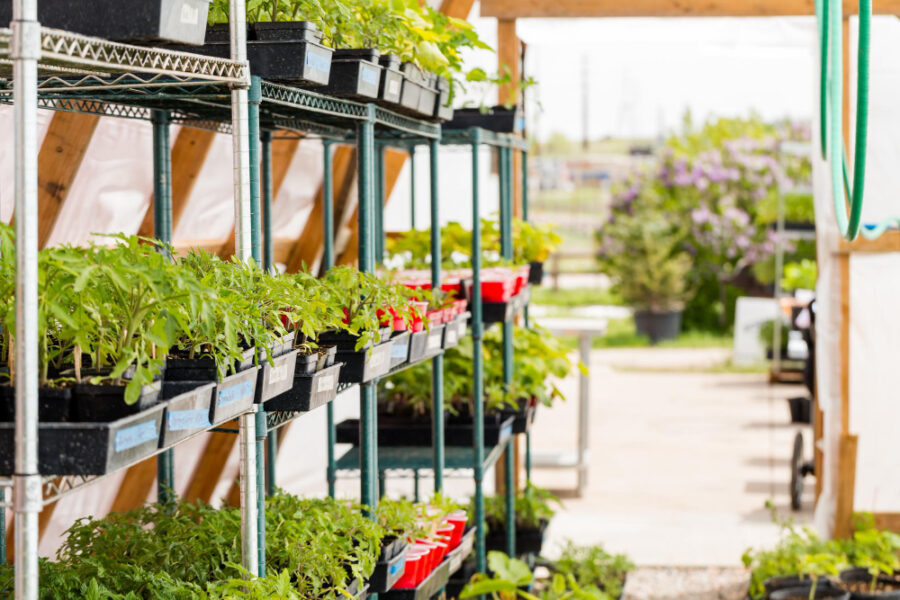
[622,567,747,600]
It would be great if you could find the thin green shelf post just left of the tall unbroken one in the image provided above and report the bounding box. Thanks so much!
[428,140,444,492]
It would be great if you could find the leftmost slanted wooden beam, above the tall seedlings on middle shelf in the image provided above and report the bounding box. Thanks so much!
[38,112,100,248]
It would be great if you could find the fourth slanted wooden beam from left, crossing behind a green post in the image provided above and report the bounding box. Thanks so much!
[285,146,356,273]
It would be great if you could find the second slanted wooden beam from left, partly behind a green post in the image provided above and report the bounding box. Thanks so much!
[138,127,216,237]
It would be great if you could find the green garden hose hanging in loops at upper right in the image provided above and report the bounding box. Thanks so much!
[816,0,900,241]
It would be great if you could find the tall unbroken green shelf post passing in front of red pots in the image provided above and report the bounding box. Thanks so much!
[472,129,487,573]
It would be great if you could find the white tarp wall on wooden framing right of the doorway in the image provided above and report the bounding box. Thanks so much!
[813,17,900,531]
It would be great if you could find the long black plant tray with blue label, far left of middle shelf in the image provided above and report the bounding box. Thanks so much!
[0,404,165,475]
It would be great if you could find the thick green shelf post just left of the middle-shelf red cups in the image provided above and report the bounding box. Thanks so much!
[356,104,378,510]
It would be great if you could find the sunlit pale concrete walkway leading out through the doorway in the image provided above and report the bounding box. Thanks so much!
[532,349,813,568]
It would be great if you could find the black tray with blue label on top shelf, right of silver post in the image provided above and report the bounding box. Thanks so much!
[179,21,334,87]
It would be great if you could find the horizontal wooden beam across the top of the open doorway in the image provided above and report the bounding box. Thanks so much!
[481,0,900,19]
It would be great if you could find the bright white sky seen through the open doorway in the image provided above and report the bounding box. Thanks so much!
[460,4,815,139]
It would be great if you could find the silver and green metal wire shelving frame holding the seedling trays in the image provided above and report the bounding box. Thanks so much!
[0,0,528,598]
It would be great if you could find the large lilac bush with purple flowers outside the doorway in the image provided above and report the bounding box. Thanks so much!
[597,118,811,330]
